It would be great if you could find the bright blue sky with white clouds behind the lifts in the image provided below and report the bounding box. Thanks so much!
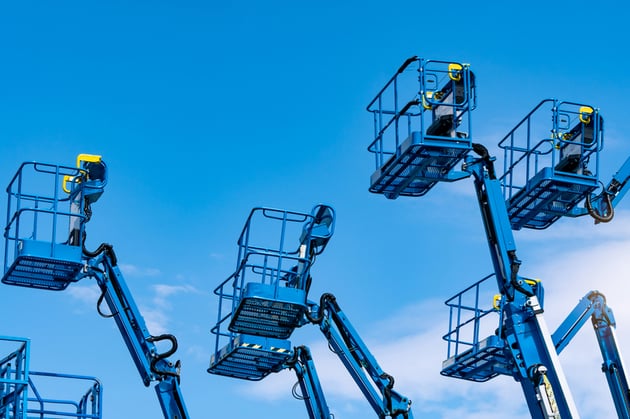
[0,0,630,419]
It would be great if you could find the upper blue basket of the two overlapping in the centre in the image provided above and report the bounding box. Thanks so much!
[214,205,333,339]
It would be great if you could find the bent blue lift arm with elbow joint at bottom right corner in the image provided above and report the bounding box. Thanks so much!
[552,291,630,419]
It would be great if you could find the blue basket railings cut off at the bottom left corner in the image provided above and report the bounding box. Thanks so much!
[0,336,102,419]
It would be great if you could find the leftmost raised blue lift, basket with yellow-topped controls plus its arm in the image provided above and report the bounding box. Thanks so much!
[2,154,189,419]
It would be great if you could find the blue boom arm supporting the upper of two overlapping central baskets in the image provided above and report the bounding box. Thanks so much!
[307,294,413,419]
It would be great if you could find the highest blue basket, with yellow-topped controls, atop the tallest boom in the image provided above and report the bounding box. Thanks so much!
[367,57,475,199]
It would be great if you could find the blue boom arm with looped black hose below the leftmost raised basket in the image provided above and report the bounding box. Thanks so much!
[83,244,190,419]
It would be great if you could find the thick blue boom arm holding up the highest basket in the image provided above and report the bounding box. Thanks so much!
[464,144,579,419]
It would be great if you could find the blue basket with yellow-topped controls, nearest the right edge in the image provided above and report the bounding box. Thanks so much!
[499,99,604,230]
